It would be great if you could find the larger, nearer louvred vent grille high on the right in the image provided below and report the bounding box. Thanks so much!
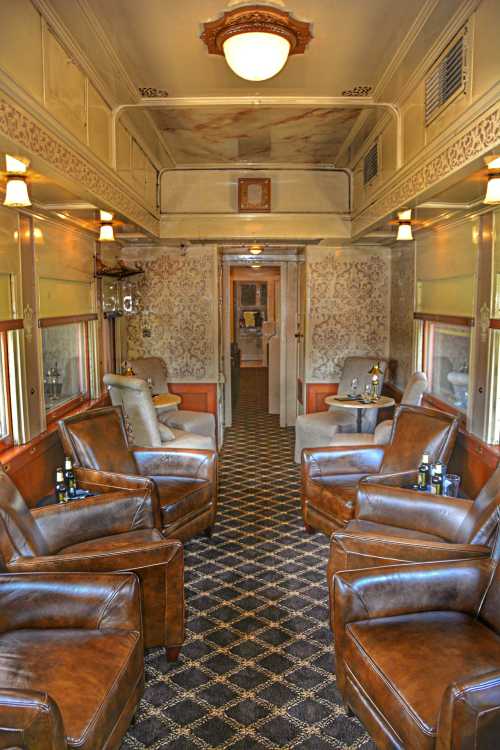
[425,30,466,125]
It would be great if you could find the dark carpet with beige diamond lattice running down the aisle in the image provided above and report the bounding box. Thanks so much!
[122,369,374,750]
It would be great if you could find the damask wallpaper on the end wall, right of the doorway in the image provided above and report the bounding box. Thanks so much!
[306,247,391,383]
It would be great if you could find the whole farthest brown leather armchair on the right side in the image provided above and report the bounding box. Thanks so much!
[302,405,458,534]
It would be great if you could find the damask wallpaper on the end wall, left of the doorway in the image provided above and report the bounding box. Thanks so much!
[127,246,218,382]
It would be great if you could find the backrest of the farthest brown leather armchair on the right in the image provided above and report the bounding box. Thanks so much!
[380,405,459,474]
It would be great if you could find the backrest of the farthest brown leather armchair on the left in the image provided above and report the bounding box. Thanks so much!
[59,406,137,474]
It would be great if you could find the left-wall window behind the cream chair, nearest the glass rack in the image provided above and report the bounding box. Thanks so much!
[40,315,95,421]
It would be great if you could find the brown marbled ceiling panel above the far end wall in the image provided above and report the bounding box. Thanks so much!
[152,107,360,164]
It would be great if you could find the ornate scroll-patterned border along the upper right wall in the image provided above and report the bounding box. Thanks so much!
[352,102,500,238]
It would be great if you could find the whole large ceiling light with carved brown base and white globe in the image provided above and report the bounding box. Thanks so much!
[201,5,312,81]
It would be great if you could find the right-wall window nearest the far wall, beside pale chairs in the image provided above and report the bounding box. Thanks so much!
[422,316,471,413]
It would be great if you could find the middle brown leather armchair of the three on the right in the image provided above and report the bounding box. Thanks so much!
[328,467,500,579]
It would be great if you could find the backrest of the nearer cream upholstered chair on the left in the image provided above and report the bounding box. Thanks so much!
[103,373,162,448]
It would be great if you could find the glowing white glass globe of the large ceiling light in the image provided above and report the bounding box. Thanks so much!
[222,31,290,81]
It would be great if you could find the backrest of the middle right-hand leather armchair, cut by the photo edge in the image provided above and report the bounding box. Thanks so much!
[455,467,500,545]
